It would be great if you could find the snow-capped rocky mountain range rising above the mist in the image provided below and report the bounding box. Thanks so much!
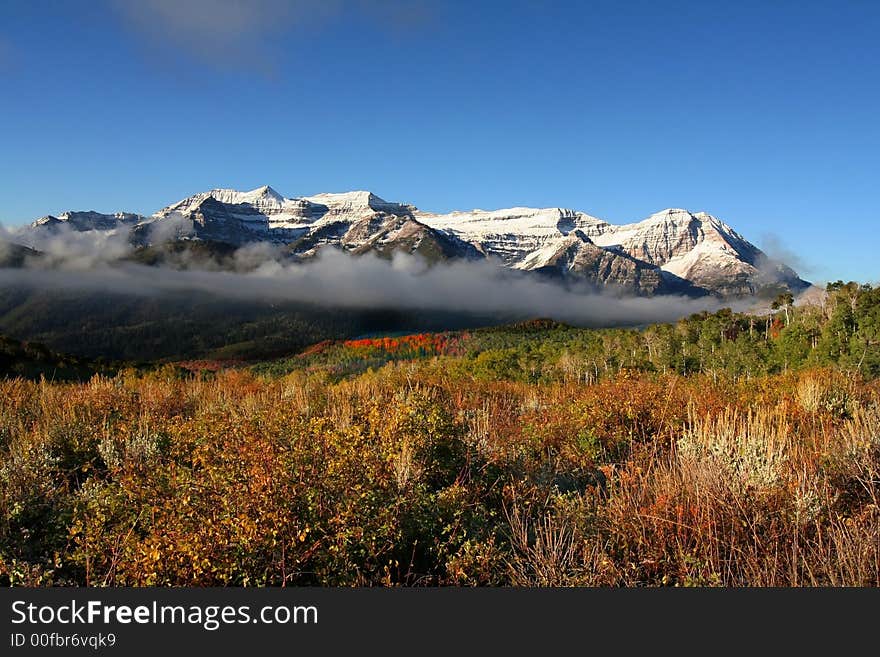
[13,186,808,295]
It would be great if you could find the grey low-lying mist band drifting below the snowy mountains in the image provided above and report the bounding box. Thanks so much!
[0,223,720,326]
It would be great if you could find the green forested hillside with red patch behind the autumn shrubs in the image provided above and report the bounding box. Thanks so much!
[258,283,880,383]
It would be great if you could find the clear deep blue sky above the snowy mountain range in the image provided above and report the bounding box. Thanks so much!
[0,0,880,281]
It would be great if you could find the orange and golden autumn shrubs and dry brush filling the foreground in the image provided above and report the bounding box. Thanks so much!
[0,364,880,586]
